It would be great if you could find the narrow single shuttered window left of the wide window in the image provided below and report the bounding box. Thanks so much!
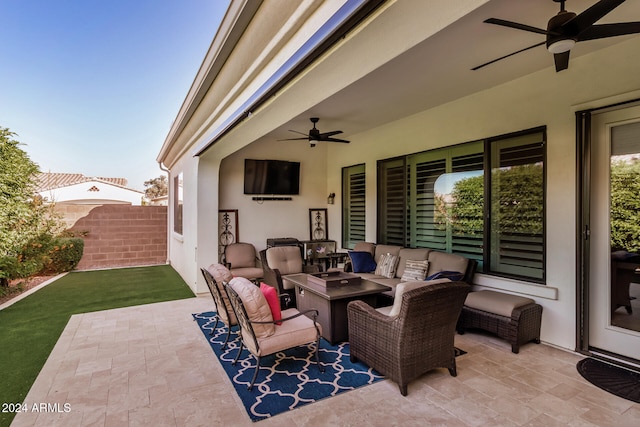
[342,165,366,249]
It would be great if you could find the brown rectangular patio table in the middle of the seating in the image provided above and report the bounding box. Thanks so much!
[286,274,391,344]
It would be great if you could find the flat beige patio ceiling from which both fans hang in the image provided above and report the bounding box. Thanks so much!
[266,0,640,144]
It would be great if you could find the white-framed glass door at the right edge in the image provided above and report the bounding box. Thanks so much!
[589,107,640,359]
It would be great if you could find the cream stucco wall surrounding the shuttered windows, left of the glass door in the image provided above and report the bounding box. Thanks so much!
[327,38,640,349]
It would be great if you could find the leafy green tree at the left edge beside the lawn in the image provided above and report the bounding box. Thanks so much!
[0,127,60,285]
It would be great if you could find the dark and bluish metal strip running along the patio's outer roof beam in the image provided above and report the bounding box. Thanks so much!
[193,0,387,157]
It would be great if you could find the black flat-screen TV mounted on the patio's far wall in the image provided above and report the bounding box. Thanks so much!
[244,159,300,195]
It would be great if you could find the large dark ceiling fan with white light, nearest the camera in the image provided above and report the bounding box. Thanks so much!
[472,0,640,72]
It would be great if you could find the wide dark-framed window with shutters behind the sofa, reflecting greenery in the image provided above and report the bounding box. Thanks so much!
[378,128,546,282]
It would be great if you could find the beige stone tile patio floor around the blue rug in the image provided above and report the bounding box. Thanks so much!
[12,297,640,427]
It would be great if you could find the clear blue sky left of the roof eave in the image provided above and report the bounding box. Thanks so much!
[0,0,229,190]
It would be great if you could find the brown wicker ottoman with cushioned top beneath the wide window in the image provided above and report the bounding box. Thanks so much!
[456,291,542,353]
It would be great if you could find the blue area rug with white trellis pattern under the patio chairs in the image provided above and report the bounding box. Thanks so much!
[193,312,384,421]
